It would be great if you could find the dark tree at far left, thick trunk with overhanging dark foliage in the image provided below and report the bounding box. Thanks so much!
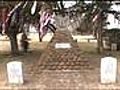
[0,1,33,55]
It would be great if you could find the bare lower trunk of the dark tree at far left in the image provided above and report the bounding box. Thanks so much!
[9,34,19,55]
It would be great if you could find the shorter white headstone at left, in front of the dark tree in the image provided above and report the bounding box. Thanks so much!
[7,61,23,84]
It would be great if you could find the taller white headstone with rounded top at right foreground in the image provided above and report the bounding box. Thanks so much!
[101,57,117,83]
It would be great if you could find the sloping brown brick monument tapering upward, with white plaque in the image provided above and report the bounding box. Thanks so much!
[33,31,93,73]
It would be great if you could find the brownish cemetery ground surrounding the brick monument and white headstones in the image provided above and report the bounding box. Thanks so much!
[0,33,120,90]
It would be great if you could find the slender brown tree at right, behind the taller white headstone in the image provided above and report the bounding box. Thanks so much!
[92,1,111,53]
